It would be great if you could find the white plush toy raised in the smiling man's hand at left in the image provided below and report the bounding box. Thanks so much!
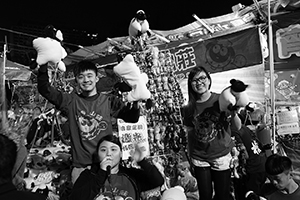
[32,26,67,72]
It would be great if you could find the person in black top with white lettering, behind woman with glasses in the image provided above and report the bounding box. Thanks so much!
[231,109,267,199]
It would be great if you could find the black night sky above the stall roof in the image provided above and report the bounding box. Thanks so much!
[0,0,253,40]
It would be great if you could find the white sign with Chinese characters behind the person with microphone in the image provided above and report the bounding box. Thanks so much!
[117,116,150,160]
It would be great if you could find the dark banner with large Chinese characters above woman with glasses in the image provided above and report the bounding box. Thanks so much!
[161,27,263,80]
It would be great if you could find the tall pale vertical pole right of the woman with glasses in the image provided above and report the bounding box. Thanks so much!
[268,0,276,153]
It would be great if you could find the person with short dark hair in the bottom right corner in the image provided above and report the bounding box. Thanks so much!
[262,154,300,200]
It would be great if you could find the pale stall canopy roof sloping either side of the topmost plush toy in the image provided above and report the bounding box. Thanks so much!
[64,1,257,66]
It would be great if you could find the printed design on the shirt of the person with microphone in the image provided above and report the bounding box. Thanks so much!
[94,188,134,200]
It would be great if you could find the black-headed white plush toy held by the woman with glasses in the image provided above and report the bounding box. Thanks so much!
[219,79,250,114]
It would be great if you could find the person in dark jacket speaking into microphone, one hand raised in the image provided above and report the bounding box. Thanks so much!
[70,135,164,200]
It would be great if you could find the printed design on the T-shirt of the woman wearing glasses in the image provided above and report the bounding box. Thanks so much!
[193,107,223,143]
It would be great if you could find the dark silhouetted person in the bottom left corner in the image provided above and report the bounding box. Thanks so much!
[0,132,46,200]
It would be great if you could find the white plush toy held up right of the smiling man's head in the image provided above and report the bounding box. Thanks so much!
[113,54,151,102]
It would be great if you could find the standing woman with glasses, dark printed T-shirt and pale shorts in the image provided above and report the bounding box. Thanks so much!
[182,66,241,200]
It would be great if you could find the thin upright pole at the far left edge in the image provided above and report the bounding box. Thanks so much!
[0,36,7,130]
